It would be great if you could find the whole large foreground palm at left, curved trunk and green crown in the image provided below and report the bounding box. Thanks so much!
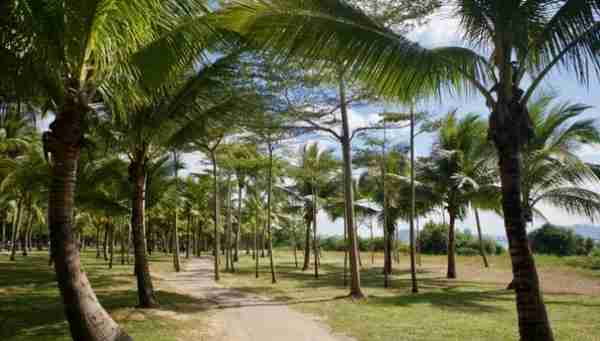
[3,0,219,341]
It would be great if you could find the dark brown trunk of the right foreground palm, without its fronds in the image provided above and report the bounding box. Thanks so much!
[489,91,554,341]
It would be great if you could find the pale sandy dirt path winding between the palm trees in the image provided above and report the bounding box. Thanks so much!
[163,258,351,341]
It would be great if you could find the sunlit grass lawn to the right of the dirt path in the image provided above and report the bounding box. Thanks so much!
[223,250,600,341]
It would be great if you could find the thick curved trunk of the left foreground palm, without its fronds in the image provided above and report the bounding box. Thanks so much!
[44,107,132,341]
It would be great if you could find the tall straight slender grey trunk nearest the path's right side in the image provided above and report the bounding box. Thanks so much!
[339,76,365,299]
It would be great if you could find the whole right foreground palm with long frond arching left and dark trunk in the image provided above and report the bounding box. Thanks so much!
[222,0,600,340]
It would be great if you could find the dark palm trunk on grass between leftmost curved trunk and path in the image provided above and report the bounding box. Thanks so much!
[128,161,158,308]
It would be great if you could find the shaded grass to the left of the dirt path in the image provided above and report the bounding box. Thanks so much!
[0,251,206,341]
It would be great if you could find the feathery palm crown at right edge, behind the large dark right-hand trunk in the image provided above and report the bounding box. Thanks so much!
[521,94,600,226]
